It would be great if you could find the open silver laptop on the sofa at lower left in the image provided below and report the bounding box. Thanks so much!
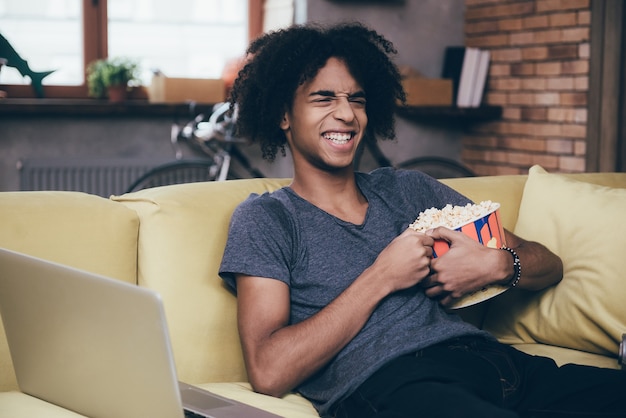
[0,249,278,418]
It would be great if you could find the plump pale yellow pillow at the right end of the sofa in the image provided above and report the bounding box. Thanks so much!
[484,166,626,356]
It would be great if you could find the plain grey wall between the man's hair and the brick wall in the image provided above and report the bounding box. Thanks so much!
[296,0,465,171]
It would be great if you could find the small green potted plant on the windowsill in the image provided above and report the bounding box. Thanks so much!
[87,57,139,102]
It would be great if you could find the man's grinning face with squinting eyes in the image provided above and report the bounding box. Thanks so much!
[280,58,367,173]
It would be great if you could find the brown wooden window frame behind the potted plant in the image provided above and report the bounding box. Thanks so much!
[0,0,265,99]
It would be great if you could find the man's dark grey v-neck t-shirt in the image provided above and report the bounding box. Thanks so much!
[220,168,488,414]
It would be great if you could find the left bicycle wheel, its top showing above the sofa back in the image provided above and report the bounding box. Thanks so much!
[126,160,219,193]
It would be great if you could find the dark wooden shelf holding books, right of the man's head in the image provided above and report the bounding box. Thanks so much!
[396,106,502,124]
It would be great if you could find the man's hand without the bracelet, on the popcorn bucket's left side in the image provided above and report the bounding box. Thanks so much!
[372,228,435,293]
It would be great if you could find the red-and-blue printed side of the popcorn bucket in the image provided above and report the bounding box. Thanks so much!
[433,204,506,257]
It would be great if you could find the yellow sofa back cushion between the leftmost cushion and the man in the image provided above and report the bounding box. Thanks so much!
[112,179,289,384]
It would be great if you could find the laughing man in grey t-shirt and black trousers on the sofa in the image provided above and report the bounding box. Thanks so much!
[220,24,626,418]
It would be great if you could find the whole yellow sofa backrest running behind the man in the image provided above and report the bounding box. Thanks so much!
[0,173,624,391]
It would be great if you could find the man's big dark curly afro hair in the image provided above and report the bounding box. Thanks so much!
[229,23,405,161]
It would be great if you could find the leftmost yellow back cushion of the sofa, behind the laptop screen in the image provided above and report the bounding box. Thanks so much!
[0,192,139,391]
